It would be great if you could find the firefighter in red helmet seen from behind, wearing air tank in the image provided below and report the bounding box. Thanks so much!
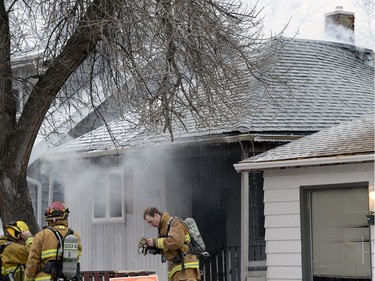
[25,201,82,281]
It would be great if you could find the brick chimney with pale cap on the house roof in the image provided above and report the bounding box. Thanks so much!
[325,6,355,45]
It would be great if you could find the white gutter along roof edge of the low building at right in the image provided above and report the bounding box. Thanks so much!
[233,154,375,172]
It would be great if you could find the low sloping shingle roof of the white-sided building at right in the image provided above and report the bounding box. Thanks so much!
[240,113,374,164]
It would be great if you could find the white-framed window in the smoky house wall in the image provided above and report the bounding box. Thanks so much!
[93,172,125,222]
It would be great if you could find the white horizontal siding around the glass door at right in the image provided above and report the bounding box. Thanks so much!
[264,163,375,281]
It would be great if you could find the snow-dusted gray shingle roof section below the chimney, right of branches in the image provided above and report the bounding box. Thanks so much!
[237,39,374,132]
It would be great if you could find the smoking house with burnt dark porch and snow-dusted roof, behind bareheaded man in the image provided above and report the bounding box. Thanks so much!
[28,6,374,281]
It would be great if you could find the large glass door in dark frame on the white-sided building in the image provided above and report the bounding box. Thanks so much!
[302,186,371,281]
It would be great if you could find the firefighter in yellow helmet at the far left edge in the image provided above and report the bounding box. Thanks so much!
[0,221,33,281]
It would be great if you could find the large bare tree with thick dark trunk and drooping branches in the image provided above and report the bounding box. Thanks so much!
[0,0,284,231]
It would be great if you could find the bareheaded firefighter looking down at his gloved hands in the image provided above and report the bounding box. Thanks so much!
[141,207,200,281]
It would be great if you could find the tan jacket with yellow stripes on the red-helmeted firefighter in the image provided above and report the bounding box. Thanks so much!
[25,220,82,281]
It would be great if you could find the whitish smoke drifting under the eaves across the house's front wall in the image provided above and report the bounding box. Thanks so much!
[42,141,179,220]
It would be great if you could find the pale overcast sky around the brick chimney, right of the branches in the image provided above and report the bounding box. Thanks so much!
[242,0,375,49]
